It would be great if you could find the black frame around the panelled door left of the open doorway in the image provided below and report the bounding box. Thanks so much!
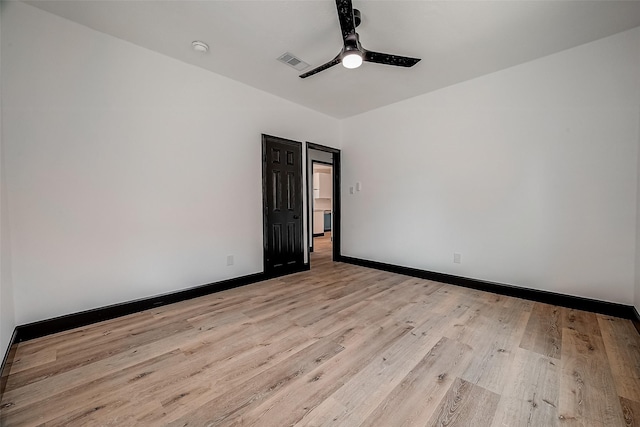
[262,133,309,277]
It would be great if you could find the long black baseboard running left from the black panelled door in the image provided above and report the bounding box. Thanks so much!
[16,272,270,342]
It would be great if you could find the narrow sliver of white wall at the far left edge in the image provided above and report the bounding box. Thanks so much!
[0,4,16,360]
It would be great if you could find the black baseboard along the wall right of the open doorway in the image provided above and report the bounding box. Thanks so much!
[340,256,640,320]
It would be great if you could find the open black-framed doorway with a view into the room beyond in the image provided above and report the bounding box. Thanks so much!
[307,142,340,264]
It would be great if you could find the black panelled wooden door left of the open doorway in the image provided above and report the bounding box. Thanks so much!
[262,135,304,276]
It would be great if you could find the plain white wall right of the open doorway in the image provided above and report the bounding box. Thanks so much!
[342,28,640,304]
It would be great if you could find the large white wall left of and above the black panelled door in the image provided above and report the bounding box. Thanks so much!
[2,2,339,324]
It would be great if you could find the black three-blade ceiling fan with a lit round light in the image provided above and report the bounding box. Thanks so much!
[300,0,420,79]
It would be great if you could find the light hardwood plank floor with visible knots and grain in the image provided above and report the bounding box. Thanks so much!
[0,236,640,426]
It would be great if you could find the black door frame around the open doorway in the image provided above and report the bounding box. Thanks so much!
[305,141,342,264]
